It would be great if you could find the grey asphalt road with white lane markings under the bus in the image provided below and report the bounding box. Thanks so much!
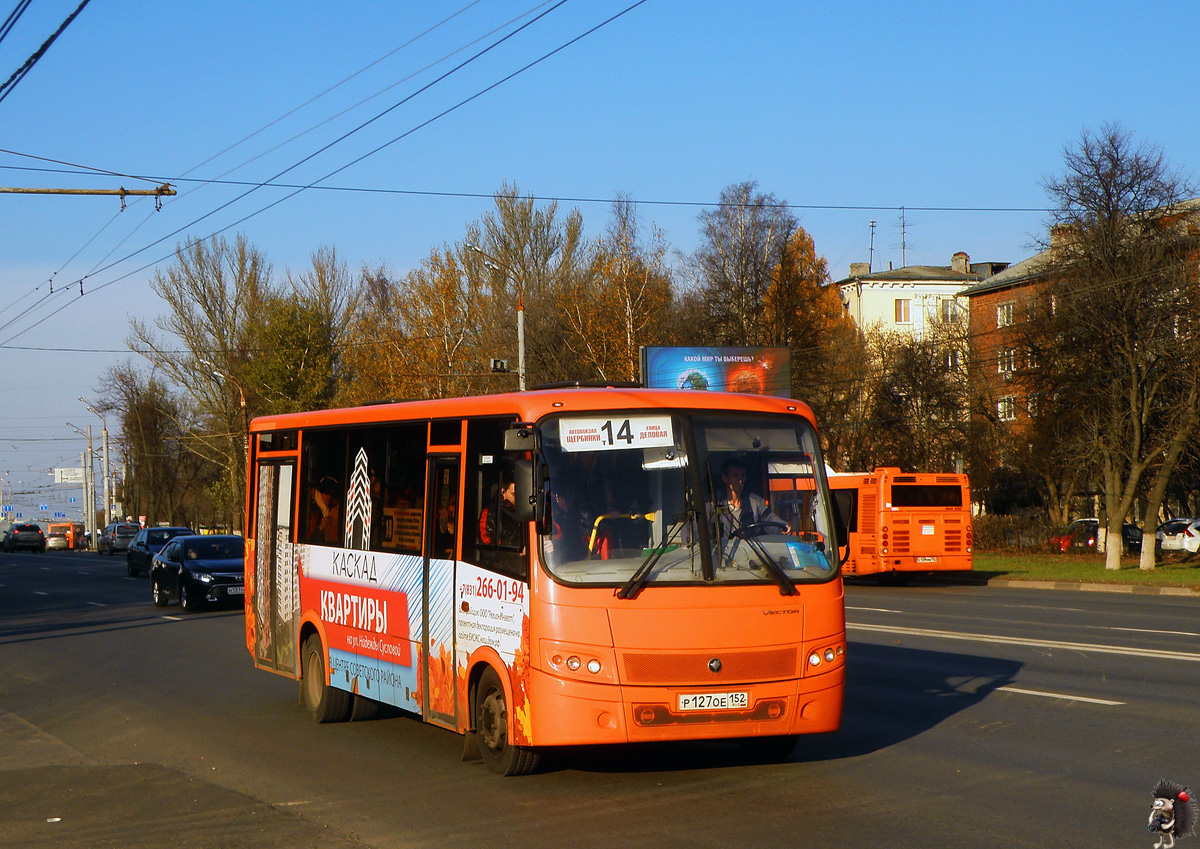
[0,553,1200,849]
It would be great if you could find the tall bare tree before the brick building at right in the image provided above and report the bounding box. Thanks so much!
[1033,126,1200,568]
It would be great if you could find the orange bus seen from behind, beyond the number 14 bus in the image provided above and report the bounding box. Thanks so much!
[829,466,972,582]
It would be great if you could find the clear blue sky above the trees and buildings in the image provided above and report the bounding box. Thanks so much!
[0,0,1200,517]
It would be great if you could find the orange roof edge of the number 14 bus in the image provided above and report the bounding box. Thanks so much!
[250,387,814,433]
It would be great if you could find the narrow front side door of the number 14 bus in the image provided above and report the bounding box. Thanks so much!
[421,457,462,729]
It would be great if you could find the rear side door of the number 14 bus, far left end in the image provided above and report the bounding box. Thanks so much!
[251,463,300,674]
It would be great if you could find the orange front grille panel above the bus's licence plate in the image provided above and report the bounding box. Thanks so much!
[620,648,798,687]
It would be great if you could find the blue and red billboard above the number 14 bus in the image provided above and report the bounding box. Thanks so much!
[642,347,792,398]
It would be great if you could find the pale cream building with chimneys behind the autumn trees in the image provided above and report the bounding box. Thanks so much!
[834,251,1008,337]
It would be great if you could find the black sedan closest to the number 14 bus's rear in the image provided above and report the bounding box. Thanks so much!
[150,534,246,610]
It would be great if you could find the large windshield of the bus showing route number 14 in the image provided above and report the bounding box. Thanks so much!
[539,411,838,589]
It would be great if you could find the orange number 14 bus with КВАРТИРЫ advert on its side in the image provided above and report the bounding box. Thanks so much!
[245,387,846,775]
